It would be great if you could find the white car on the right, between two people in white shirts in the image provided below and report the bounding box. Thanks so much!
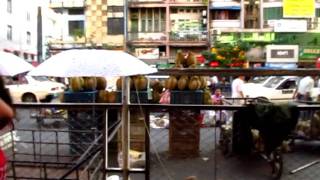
[243,76,319,101]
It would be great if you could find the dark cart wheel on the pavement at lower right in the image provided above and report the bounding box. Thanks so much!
[270,150,283,180]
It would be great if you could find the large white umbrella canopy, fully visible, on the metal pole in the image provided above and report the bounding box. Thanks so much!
[29,49,157,77]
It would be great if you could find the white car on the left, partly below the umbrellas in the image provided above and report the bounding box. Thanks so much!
[5,75,66,102]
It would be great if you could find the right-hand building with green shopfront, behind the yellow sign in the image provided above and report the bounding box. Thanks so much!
[209,0,320,61]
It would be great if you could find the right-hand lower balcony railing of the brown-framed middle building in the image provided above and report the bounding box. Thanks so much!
[170,31,208,41]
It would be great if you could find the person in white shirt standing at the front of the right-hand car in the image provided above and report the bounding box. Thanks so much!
[231,75,245,104]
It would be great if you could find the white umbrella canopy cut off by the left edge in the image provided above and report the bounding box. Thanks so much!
[0,51,34,76]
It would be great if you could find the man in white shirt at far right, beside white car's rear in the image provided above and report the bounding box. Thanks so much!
[293,76,314,101]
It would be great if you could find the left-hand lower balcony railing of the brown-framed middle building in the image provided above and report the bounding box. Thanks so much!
[128,32,167,42]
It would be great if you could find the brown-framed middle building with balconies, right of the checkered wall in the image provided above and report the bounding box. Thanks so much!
[127,0,209,63]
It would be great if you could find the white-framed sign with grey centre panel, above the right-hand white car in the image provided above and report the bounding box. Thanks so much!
[266,45,299,63]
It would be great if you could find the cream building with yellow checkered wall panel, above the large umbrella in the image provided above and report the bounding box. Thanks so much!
[49,0,124,52]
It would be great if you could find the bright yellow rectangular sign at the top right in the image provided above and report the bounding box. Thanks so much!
[283,0,315,18]
